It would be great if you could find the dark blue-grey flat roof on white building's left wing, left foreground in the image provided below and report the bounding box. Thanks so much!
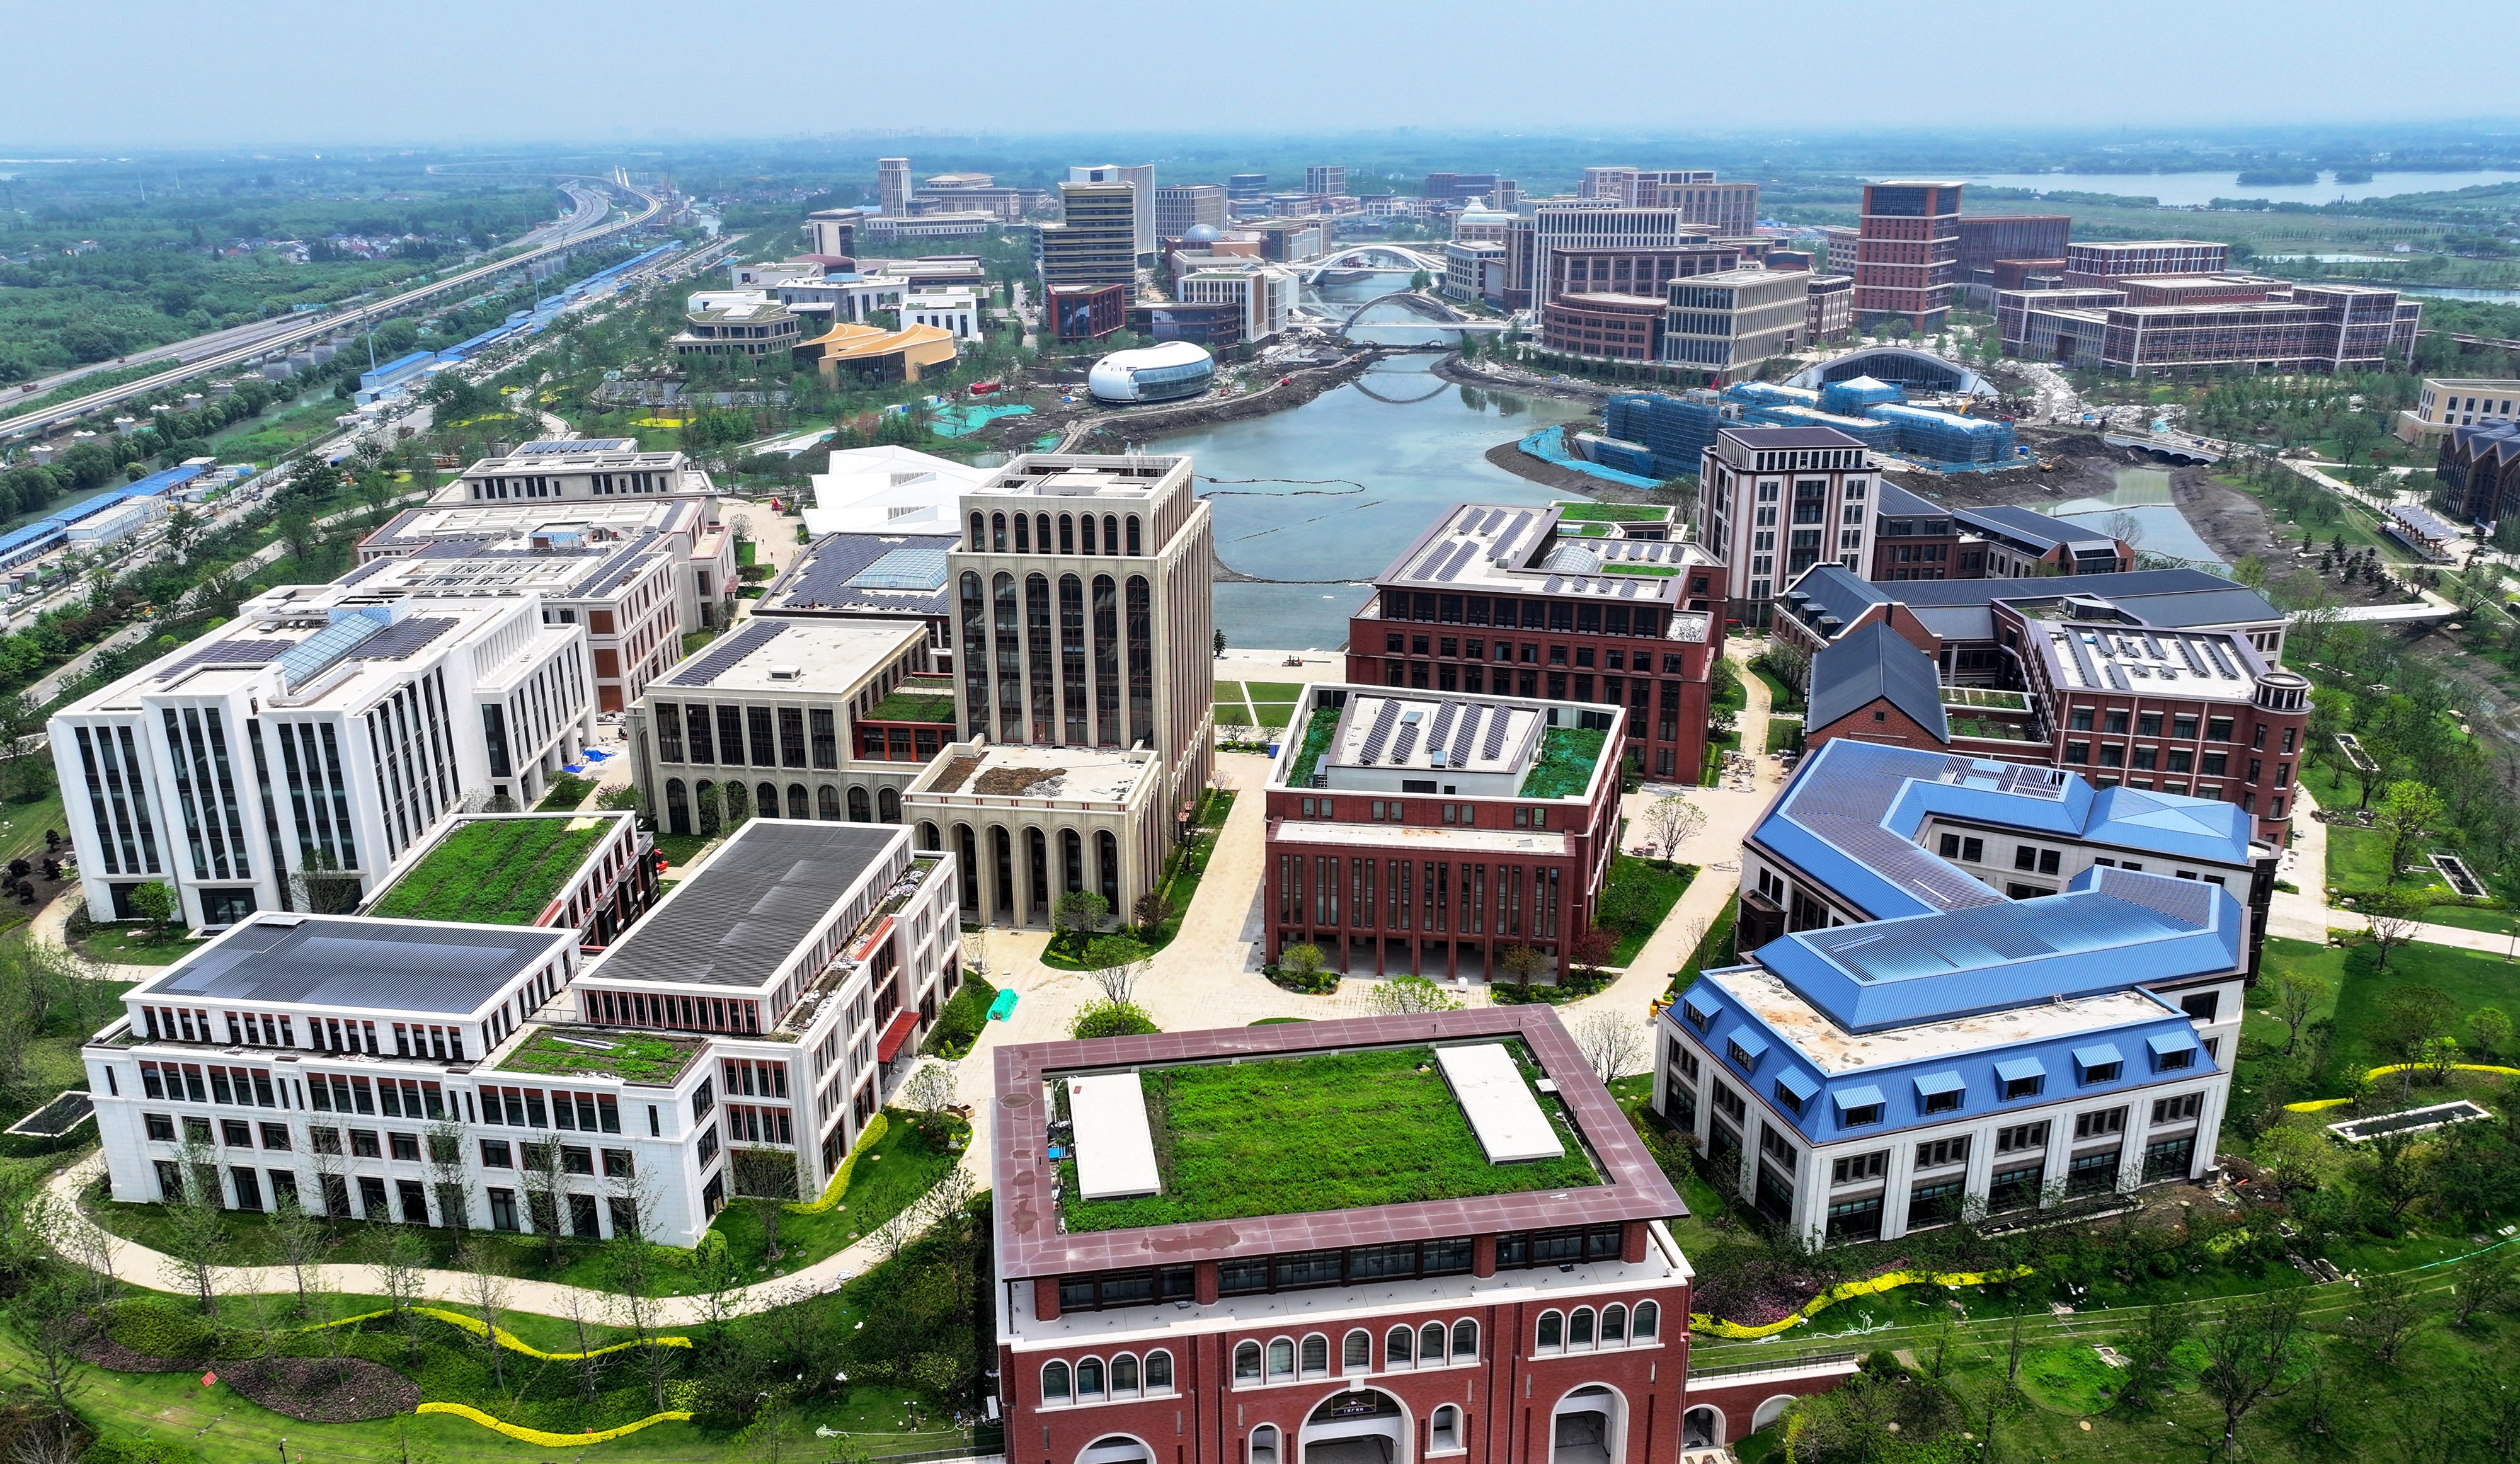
[131,912,577,1015]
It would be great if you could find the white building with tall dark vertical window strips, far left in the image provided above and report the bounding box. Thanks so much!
[48,585,595,930]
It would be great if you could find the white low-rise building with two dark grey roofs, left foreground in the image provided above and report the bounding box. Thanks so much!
[83,821,960,1245]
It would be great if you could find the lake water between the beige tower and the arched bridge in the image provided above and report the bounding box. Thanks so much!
[1147,355,1590,650]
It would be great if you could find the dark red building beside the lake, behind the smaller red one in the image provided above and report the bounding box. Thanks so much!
[1348,504,1726,784]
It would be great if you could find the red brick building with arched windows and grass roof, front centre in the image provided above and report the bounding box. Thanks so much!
[993,1005,1852,1464]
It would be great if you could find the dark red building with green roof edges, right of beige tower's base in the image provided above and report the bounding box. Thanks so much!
[1260,685,1623,980]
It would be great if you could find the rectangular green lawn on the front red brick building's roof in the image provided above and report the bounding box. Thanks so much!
[1061,1043,1600,1230]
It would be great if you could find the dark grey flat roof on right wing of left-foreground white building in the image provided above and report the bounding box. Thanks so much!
[585,819,907,993]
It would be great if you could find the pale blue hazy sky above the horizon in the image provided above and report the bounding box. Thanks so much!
[0,0,2520,156]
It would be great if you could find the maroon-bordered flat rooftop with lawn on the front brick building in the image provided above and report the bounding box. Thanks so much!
[990,1005,1686,1278]
